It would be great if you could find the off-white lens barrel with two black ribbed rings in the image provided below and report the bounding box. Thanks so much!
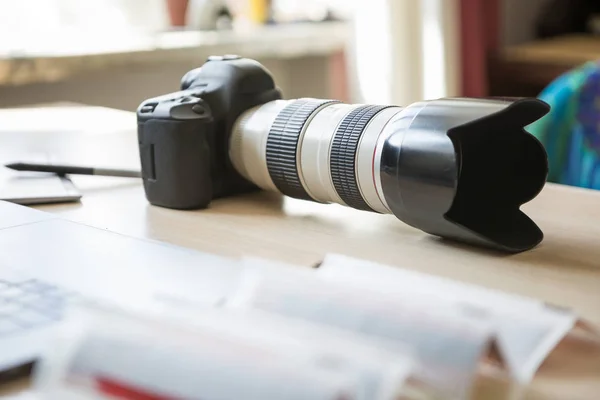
[229,99,402,213]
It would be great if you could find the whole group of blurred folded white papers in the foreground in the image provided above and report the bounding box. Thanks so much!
[30,255,596,400]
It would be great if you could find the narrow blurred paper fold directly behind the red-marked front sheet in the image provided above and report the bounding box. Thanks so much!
[166,308,414,400]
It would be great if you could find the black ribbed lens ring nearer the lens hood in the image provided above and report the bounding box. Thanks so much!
[329,105,390,211]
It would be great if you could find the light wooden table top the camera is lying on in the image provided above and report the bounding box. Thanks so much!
[0,104,600,400]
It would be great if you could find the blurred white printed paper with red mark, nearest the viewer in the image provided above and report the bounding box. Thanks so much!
[35,307,406,400]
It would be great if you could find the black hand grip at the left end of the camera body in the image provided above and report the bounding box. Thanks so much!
[138,119,213,209]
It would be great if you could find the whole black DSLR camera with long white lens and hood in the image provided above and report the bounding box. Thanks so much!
[137,55,549,252]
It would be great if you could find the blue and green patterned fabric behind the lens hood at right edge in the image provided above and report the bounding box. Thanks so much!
[527,62,600,189]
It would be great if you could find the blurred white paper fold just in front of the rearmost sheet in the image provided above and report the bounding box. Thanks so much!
[228,259,494,398]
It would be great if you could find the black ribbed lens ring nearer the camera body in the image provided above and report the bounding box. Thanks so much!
[267,99,337,200]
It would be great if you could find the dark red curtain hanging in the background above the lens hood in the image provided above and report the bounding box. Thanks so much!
[460,0,501,97]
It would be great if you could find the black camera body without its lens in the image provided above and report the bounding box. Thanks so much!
[137,56,282,209]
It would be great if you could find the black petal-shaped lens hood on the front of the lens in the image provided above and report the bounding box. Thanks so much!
[380,98,550,253]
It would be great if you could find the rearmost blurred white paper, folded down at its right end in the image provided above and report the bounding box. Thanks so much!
[317,254,577,383]
